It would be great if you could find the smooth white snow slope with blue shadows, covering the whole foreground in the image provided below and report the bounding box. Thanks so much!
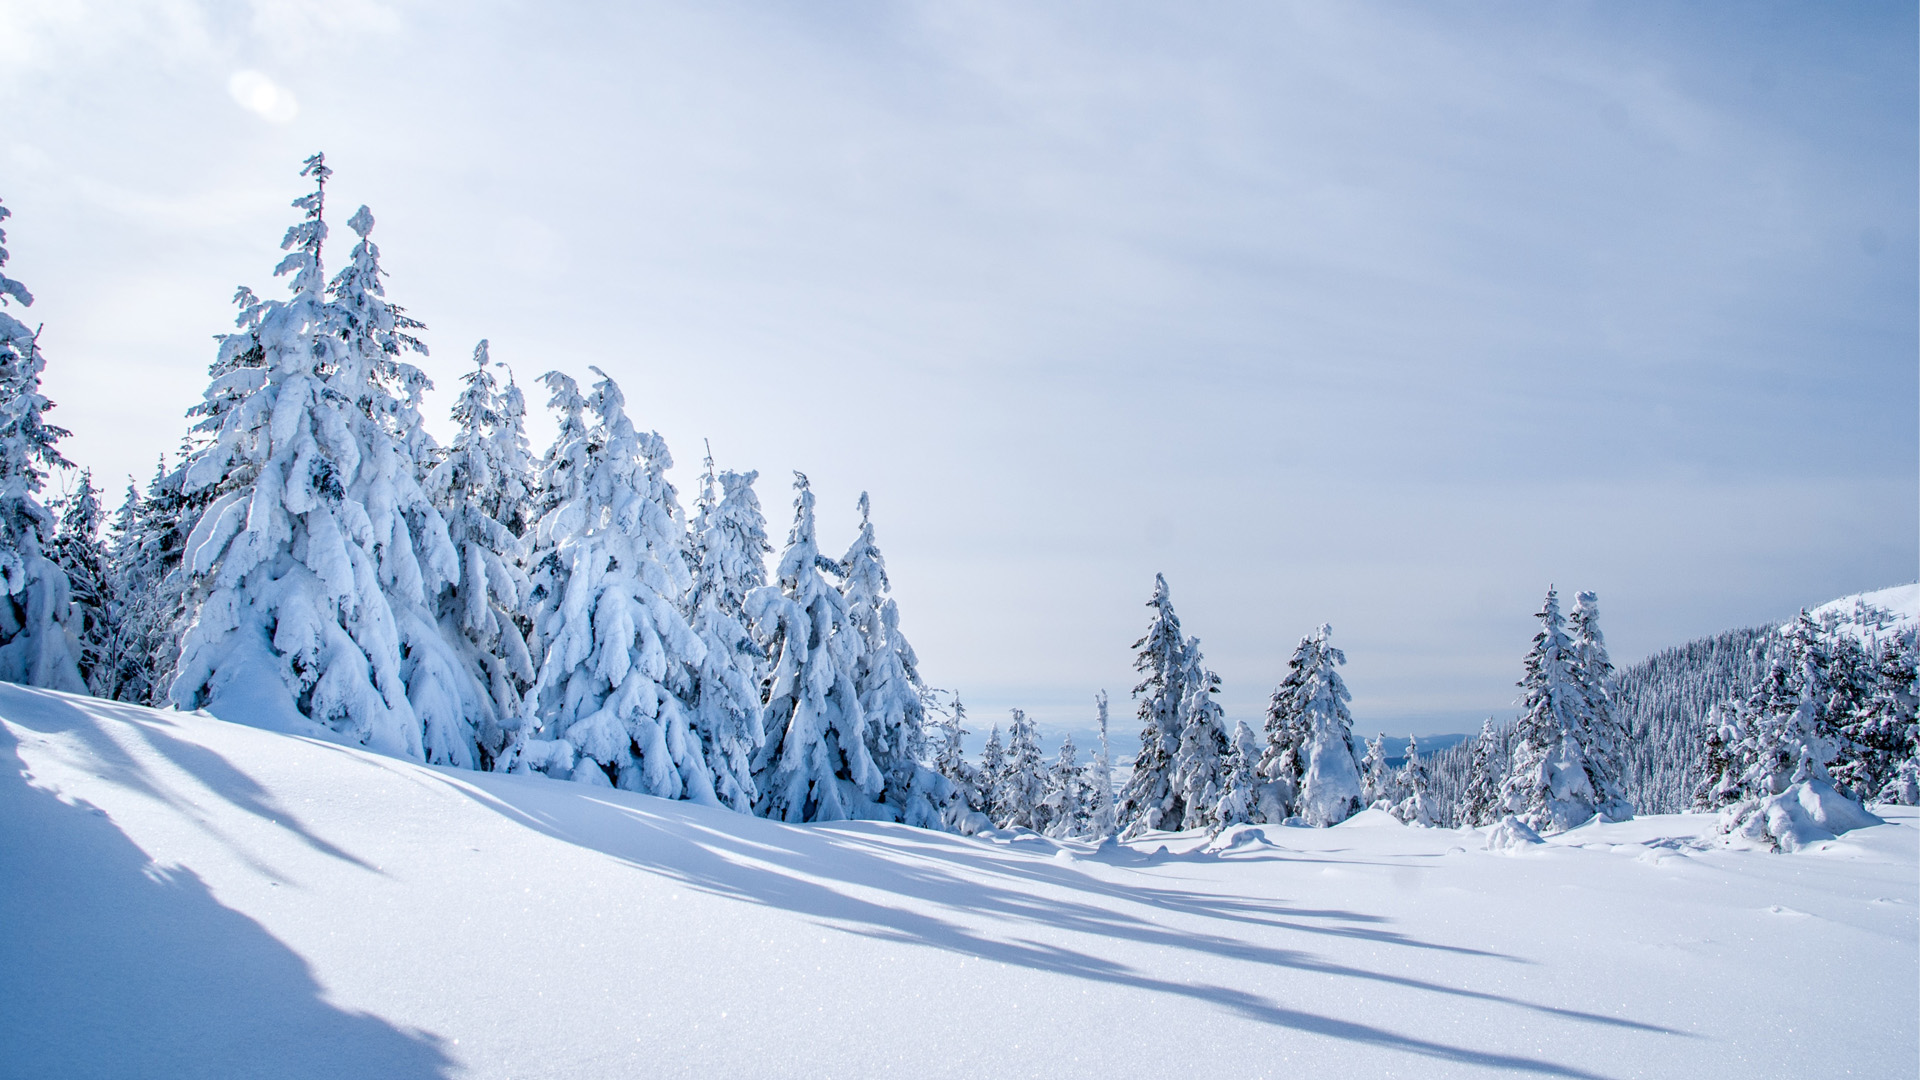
[0,686,1920,1080]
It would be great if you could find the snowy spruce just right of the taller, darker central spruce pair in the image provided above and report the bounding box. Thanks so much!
[1267,625,1365,828]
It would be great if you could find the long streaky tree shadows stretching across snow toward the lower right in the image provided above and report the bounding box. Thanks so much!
[442,773,1692,1078]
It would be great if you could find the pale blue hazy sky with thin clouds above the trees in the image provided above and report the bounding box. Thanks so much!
[0,0,1920,732]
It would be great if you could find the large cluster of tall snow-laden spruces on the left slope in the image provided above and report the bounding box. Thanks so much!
[0,154,954,826]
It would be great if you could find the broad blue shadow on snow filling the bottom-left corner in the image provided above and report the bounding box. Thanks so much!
[0,688,453,1080]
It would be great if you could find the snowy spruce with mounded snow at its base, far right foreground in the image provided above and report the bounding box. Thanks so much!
[1720,611,1880,851]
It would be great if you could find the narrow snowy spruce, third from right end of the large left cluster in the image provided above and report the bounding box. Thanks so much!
[691,454,774,813]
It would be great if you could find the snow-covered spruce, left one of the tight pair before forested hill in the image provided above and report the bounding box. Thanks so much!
[1500,588,1599,832]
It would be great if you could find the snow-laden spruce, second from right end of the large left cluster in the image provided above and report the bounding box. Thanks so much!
[747,473,893,821]
